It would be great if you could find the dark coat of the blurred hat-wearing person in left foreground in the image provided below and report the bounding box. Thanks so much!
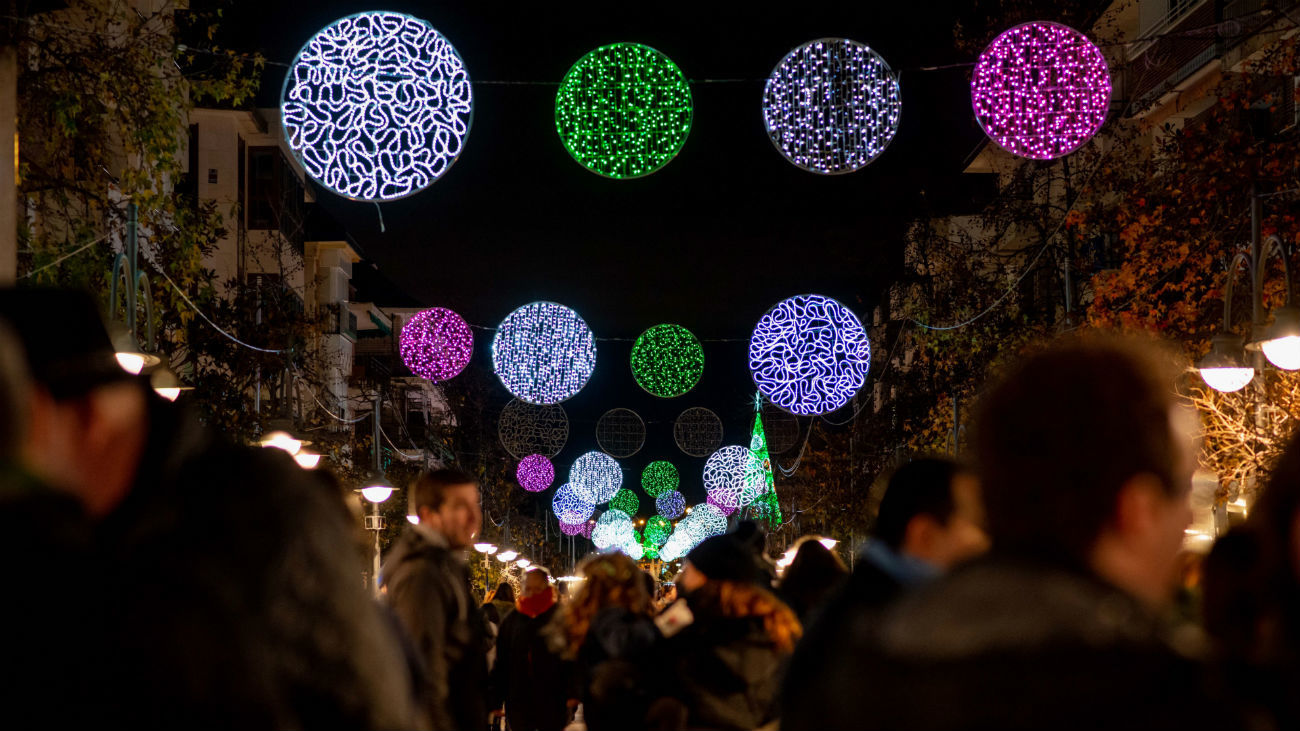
[91,398,417,730]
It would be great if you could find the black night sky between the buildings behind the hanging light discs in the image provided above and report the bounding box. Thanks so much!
[226,0,982,496]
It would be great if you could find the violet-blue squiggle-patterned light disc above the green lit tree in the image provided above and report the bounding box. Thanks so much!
[749,294,871,416]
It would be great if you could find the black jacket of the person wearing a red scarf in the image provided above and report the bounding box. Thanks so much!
[489,605,569,731]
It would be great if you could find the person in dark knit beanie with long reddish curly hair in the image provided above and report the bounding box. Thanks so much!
[660,529,802,730]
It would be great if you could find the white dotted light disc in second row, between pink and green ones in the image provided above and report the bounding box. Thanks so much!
[491,302,595,405]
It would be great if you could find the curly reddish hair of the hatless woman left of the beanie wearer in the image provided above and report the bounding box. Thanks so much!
[555,553,654,659]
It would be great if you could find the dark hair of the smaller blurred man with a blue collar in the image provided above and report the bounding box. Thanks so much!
[871,457,965,550]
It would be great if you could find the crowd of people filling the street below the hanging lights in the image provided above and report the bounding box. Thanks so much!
[0,289,1300,731]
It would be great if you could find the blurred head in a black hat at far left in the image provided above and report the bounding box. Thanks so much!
[0,289,148,516]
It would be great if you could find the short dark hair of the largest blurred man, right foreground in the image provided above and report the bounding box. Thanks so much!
[974,336,1191,562]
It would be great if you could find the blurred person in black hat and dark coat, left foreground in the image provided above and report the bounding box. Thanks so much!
[0,289,417,728]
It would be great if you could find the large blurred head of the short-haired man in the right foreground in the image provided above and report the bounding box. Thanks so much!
[974,337,1196,604]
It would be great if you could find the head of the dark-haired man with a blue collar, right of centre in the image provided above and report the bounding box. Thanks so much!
[872,457,988,570]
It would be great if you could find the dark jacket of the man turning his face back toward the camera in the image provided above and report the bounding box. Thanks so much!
[381,525,488,731]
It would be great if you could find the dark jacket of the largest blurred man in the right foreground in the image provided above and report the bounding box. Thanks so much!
[811,557,1225,731]
